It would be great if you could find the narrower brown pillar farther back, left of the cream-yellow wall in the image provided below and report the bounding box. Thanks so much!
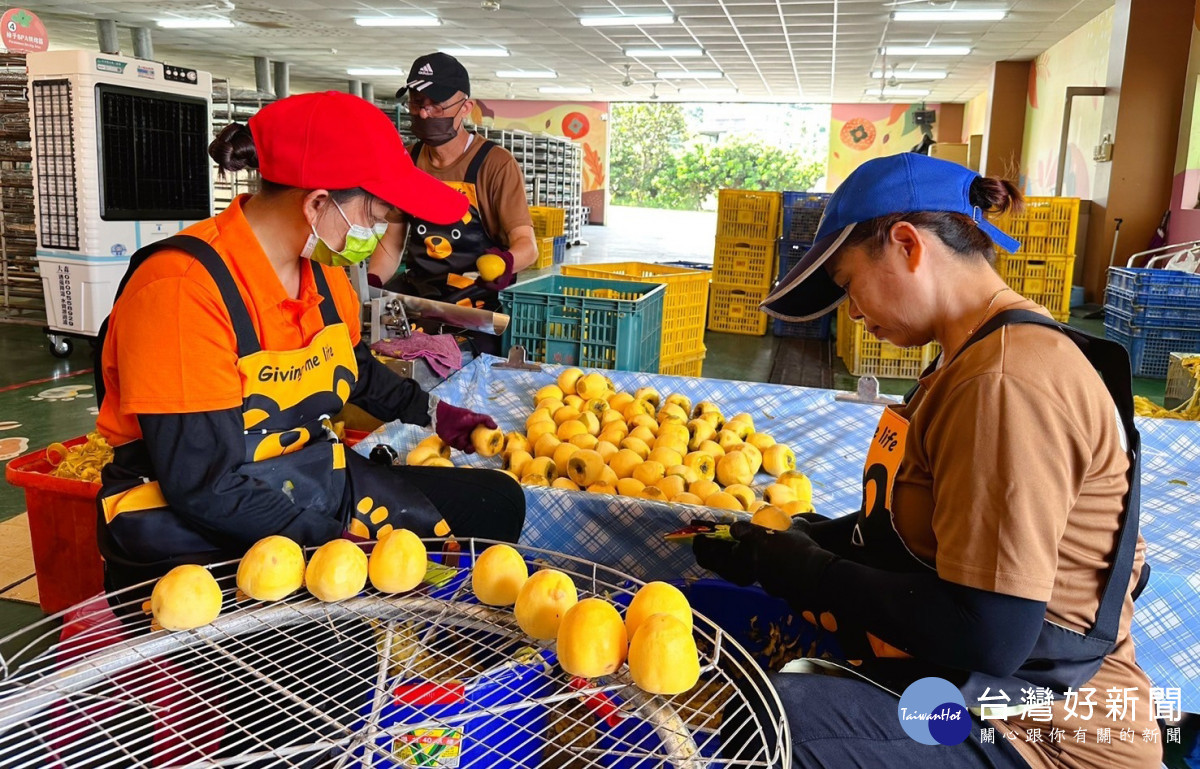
[979,61,1033,182]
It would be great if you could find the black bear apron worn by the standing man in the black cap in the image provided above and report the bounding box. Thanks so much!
[389,137,503,310]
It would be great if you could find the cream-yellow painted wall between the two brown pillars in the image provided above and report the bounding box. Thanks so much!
[1020,7,1114,199]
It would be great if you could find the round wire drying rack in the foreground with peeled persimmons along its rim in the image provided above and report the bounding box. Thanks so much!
[0,540,791,769]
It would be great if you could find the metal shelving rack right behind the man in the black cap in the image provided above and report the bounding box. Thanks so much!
[470,126,583,246]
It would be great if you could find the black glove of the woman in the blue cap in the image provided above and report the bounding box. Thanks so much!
[692,521,838,612]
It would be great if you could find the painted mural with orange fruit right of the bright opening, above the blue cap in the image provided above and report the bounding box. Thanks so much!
[826,103,940,191]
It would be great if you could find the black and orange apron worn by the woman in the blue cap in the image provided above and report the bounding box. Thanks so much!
[805,310,1150,709]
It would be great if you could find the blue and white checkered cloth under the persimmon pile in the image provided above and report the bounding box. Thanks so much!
[356,356,1200,713]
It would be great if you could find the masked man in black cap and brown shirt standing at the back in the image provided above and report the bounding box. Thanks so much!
[368,53,538,326]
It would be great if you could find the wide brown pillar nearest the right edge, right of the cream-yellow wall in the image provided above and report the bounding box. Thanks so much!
[1082,0,1196,297]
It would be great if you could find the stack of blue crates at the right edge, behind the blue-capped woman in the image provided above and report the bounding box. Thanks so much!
[1104,268,1200,379]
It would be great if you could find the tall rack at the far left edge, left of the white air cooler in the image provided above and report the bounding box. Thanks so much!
[0,54,46,325]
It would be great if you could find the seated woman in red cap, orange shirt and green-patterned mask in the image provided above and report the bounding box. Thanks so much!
[97,92,524,588]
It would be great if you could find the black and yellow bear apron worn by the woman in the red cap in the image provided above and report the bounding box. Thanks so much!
[97,235,442,578]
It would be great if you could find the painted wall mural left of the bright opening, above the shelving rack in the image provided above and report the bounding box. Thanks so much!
[472,98,608,224]
